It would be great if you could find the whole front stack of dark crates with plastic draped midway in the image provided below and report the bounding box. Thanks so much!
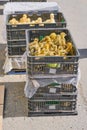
[26,13,79,116]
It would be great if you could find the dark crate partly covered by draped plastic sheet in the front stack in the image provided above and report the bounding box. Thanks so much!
[29,79,77,100]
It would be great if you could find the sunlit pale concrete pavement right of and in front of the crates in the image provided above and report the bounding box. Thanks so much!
[1,0,87,130]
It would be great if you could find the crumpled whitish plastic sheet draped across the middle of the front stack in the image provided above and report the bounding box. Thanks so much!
[24,71,81,98]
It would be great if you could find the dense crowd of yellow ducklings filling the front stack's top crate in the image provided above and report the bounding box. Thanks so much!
[28,32,75,56]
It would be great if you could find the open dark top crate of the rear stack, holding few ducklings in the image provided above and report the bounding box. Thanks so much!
[6,11,67,30]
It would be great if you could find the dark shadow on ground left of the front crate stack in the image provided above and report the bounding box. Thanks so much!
[4,82,28,118]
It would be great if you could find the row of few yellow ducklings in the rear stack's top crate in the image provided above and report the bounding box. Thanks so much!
[9,13,55,25]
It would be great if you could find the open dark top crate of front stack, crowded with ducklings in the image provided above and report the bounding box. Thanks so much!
[26,28,79,64]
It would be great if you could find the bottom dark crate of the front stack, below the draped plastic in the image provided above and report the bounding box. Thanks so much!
[28,100,76,112]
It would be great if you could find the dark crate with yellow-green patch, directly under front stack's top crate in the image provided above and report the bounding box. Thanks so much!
[27,61,78,77]
